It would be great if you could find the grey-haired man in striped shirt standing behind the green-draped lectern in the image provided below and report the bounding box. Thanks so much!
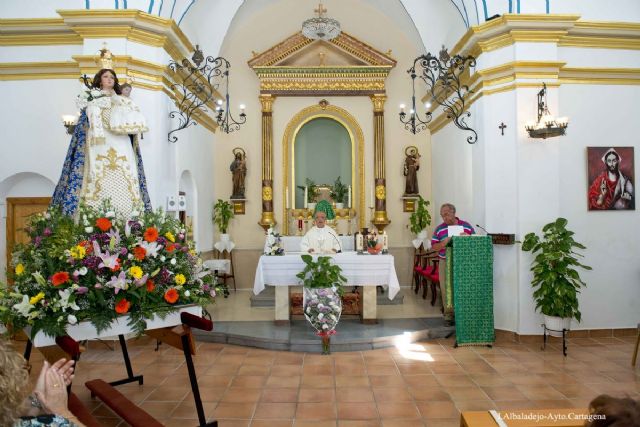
[431,203,476,323]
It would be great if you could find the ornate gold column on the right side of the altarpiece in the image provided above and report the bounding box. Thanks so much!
[371,94,391,232]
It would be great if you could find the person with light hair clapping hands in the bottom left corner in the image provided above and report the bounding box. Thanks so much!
[0,339,83,427]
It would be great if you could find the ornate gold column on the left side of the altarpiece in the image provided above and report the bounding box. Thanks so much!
[258,94,276,231]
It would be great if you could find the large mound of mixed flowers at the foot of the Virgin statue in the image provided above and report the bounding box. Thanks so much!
[0,204,216,342]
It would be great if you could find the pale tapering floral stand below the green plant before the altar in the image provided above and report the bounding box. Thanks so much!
[303,288,342,354]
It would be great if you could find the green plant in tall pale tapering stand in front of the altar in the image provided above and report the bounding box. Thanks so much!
[296,254,347,354]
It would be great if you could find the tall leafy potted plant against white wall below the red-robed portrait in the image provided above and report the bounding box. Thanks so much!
[522,218,591,336]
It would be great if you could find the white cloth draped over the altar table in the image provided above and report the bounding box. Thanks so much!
[253,252,400,299]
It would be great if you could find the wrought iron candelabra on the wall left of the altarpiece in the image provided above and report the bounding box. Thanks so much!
[167,45,247,142]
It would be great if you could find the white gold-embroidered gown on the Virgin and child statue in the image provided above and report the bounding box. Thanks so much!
[78,94,148,217]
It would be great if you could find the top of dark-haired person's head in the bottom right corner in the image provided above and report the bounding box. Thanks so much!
[584,394,640,427]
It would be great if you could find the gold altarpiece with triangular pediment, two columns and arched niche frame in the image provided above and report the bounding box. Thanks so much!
[248,32,396,234]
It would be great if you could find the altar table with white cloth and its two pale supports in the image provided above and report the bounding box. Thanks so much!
[253,252,400,322]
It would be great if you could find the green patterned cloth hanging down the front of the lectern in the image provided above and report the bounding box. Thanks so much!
[447,236,495,345]
